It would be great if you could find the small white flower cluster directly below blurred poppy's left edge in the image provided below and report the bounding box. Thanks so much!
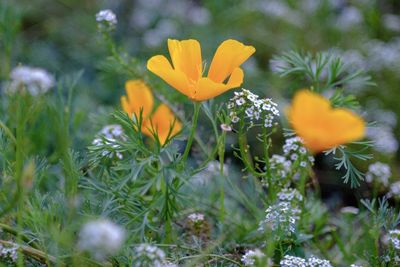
[283,136,314,168]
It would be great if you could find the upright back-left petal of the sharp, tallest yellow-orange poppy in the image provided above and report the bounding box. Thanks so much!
[168,39,203,81]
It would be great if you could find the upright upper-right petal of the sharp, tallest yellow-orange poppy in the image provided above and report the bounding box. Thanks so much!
[208,39,256,83]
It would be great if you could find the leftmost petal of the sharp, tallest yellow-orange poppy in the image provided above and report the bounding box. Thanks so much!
[147,55,194,97]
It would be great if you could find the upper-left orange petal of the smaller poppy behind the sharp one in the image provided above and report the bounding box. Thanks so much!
[123,80,154,119]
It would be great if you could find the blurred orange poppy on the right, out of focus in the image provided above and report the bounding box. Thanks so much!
[288,90,365,153]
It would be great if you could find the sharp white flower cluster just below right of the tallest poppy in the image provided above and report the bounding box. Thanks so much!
[228,89,279,128]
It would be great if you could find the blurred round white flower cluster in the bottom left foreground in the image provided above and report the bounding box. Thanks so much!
[78,219,125,260]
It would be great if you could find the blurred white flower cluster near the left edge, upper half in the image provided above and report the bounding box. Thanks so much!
[8,66,55,96]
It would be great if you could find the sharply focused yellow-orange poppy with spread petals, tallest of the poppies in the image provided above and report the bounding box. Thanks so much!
[147,39,256,101]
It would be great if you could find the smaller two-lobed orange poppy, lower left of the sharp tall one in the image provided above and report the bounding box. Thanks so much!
[121,80,182,145]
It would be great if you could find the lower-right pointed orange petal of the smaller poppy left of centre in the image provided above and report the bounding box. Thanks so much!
[146,104,182,145]
